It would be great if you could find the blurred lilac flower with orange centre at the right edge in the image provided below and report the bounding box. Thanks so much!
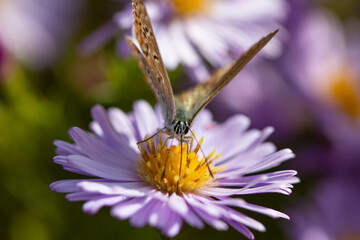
[284,9,360,171]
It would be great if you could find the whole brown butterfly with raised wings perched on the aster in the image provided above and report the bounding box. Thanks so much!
[125,0,279,176]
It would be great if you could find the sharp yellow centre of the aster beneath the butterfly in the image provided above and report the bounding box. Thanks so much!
[136,133,225,195]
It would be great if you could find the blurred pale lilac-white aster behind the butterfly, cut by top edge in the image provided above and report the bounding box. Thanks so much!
[82,0,288,81]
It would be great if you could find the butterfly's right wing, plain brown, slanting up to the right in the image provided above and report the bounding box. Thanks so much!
[175,30,279,124]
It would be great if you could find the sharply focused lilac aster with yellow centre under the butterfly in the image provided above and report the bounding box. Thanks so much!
[50,101,298,239]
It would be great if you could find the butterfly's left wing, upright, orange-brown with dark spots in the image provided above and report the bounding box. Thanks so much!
[132,0,175,126]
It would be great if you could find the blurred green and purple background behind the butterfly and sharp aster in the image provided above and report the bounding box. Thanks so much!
[0,0,360,240]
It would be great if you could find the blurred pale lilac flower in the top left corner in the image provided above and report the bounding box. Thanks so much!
[0,0,81,69]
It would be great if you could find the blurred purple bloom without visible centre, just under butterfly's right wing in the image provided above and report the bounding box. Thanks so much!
[209,60,305,140]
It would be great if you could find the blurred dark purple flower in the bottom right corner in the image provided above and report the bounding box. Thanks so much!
[286,178,360,240]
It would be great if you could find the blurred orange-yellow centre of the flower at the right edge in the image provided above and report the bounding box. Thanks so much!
[329,67,360,119]
